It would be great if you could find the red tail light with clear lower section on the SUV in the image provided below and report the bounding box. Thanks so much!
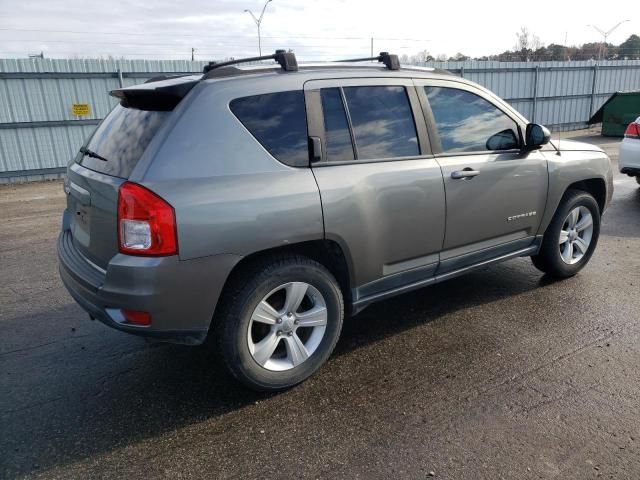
[118,182,178,256]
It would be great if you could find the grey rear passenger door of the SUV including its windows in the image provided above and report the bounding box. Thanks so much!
[305,78,445,303]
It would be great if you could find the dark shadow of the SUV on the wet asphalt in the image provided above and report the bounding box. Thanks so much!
[0,259,552,476]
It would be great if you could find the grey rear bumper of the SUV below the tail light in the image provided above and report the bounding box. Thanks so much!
[58,230,239,345]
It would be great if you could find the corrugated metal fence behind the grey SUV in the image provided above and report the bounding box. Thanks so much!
[0,59,640,183]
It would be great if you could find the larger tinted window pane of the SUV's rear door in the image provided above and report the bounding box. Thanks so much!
[344,87,420,160]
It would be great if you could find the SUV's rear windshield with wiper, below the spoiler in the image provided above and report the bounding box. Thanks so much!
[80,105,171,178]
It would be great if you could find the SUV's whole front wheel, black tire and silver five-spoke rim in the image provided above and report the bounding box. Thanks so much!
[531,190,600,278]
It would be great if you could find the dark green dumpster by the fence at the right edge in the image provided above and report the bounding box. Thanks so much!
[589,90,640,137]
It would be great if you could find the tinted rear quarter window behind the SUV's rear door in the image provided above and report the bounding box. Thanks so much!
[230,90,309,166]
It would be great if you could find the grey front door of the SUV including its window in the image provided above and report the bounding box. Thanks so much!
[416,80,548,273]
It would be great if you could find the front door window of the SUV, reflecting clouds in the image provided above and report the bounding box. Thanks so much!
[425,87,519,152]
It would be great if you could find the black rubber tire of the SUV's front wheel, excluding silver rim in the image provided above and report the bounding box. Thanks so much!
[531,190,600,278]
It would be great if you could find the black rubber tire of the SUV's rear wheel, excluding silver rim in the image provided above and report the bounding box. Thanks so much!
[214,256,344,391]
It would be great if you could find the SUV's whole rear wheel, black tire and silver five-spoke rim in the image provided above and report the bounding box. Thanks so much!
[214,256,344,391]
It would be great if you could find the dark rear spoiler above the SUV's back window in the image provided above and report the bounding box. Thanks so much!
[109,76,200,111]
